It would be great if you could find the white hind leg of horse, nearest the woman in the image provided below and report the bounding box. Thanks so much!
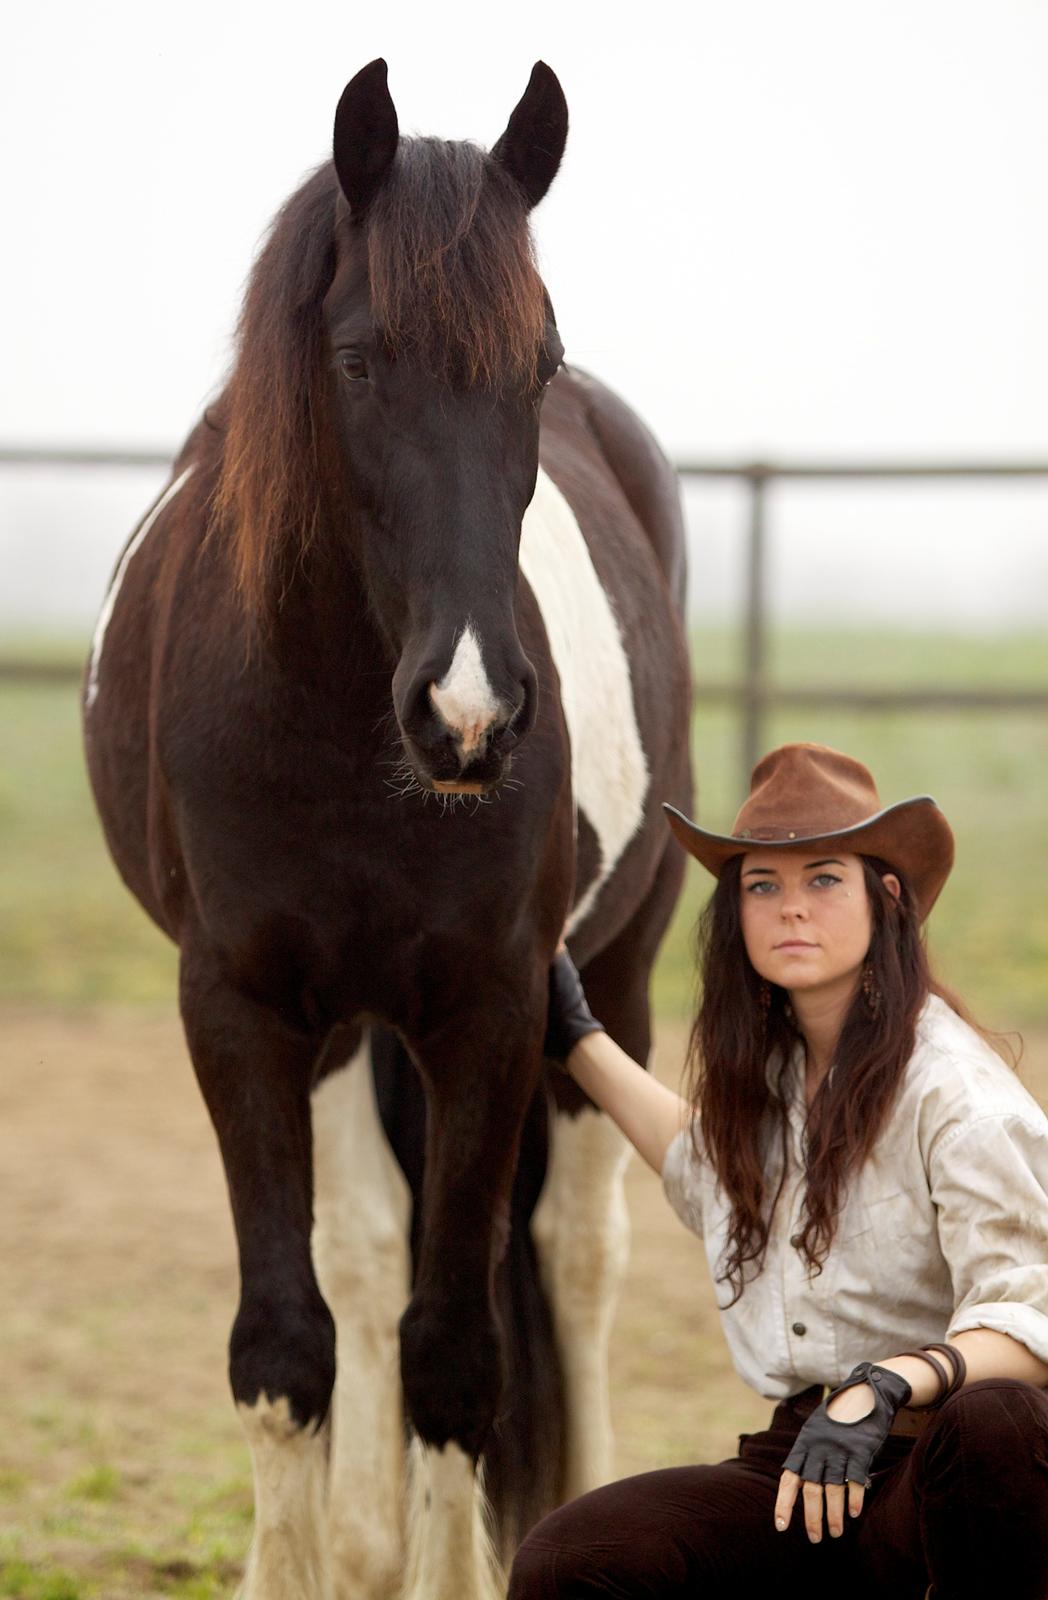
[531,1110,630,1499]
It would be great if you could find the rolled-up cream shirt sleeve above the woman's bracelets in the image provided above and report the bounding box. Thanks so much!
[930,1112,1048,1362]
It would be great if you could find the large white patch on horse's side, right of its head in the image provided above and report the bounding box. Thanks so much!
[520,469,650,933]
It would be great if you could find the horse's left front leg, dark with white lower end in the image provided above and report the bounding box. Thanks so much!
[181,952,334,1600]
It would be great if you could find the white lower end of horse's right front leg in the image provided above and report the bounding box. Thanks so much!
[405,1438,506,1600]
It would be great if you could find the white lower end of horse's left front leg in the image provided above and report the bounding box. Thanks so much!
[237,1395,334,1600]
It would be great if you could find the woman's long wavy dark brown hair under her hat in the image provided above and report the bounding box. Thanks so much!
[688,856,998,1304]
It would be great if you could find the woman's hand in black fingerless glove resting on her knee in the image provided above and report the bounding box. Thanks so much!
[774,1362,912,1544]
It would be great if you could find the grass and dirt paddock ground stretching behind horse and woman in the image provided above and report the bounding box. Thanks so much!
[0,620,1048,1600]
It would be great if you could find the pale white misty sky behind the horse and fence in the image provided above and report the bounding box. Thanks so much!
[0,0,1048,635]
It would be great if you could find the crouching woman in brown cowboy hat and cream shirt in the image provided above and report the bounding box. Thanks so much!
[509,744,1048,1600]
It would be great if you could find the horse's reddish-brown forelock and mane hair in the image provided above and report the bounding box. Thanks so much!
[211,139,546,616]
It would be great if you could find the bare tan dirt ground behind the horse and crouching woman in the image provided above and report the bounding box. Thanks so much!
[0,1013,1048,1600]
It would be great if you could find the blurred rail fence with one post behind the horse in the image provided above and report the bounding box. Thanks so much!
[0,445,1048,792]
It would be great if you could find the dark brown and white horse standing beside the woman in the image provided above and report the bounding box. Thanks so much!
[83,61,690,1600]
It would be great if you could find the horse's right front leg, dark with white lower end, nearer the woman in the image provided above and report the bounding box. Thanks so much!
[400,992,546,1600]
